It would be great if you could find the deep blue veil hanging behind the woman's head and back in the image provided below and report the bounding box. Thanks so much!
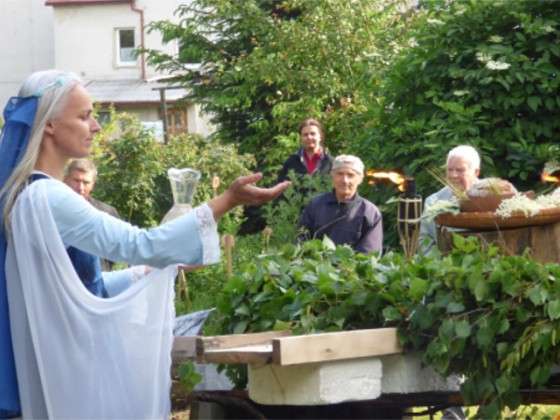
[0,95,40,418]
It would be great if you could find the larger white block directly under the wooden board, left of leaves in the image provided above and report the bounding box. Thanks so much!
[248,357,382,405]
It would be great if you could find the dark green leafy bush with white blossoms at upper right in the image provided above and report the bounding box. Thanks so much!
[358,0,560,194]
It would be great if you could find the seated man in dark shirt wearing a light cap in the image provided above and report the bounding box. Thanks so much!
[300,155,383,253]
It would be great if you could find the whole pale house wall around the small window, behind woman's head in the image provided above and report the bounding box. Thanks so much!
[0,0,213,136]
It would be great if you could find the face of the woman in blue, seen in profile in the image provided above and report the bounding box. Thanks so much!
[45,85,101,159]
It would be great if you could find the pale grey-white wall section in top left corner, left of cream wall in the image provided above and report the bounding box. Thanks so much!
[0,0,54,109]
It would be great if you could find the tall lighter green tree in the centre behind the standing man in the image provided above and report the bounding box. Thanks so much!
[145,0,411,176]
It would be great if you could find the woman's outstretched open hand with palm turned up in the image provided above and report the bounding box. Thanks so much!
[208,173,291,219]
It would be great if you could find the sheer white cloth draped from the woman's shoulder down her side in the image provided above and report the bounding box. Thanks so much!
[6,182,176,419]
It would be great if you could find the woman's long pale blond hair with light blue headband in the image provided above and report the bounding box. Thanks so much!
[0,70,81,231]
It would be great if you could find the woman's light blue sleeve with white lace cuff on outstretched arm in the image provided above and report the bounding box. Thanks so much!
[41,179,220,268]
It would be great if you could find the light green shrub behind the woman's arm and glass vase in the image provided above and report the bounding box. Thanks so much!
[93,107,254,226]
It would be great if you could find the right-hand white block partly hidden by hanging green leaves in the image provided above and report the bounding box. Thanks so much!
[380,353,461,394]
